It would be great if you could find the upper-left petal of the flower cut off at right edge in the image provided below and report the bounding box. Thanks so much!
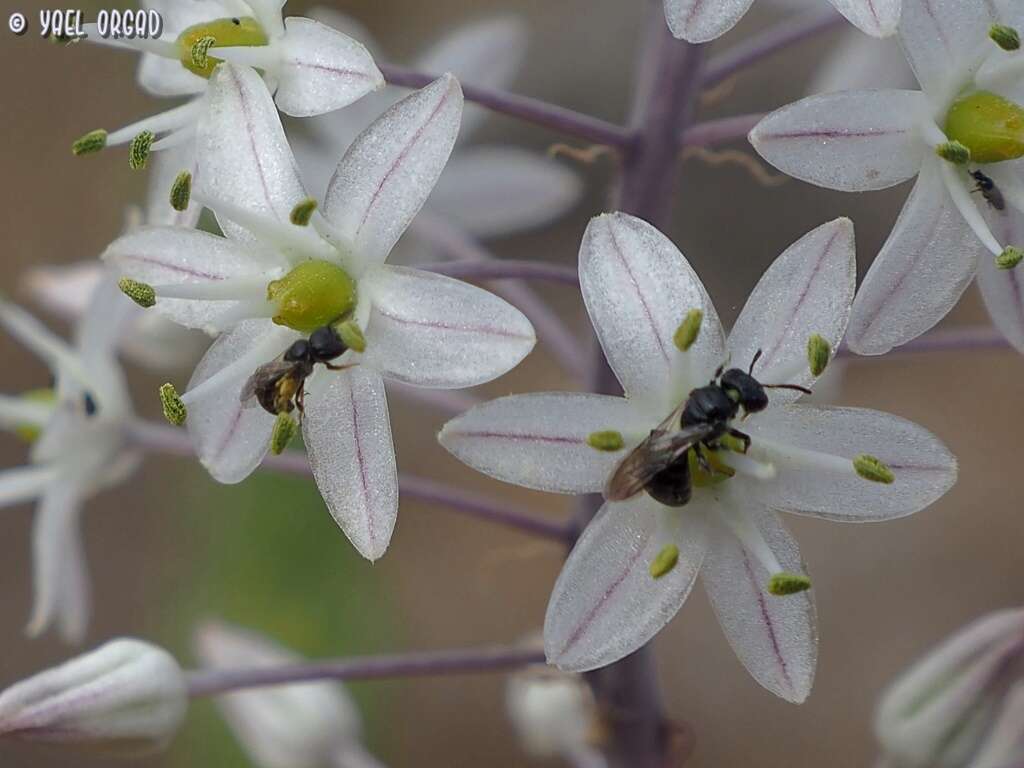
[899,0,998,97]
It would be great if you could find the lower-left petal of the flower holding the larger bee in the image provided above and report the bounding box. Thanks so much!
[544,495,707,672]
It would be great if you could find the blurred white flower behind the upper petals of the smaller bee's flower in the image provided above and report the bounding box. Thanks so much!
[292,8,583,249]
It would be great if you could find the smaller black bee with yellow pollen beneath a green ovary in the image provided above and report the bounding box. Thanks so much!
[241,326,348,416]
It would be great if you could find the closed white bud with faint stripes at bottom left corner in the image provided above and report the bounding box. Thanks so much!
[0,639,188,756]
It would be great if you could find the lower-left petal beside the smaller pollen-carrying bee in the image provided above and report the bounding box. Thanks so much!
[185,319,286,483]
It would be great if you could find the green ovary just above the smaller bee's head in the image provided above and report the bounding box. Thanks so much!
[266,261,355,333]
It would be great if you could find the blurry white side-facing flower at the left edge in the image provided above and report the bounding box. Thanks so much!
[0,280,139,642]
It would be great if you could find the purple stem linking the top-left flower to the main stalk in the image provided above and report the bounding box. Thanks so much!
[380,65,633,148]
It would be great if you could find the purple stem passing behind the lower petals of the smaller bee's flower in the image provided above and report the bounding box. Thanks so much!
[128,421,569,543]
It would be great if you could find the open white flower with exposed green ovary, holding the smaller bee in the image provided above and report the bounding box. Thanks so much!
[104,65,536,559]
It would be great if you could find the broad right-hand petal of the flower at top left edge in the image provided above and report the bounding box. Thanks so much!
[274,16,384,118]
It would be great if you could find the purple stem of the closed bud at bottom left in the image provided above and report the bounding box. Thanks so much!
[187,647,545,698]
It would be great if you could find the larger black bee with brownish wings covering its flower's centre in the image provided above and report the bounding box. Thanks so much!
[604,350,810,507]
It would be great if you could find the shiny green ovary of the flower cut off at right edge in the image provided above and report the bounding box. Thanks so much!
[945,91,1024,163]
